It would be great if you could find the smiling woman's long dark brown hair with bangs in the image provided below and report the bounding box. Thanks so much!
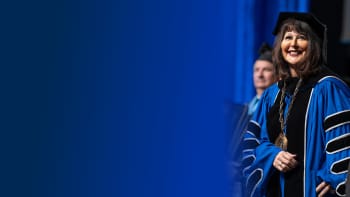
[272,19,325,80]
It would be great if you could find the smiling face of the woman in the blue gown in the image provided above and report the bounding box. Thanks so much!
[281,31,309,65]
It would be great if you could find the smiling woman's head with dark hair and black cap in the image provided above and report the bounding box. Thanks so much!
[273,13,327,78]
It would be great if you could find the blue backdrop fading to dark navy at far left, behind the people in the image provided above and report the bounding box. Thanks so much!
[0,0,308,197]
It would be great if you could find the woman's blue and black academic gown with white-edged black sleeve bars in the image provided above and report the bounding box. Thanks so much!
[242,67,350,197]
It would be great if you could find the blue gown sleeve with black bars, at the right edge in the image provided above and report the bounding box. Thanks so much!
[308,77,350,196]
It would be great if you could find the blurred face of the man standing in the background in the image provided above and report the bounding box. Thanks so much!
[253,60,275,90]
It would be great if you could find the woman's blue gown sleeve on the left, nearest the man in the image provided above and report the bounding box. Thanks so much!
[242,85,281,197]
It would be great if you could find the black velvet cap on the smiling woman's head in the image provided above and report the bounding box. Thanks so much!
[272,12,327,40]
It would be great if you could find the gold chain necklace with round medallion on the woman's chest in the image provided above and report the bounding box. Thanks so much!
[275,78,303,151]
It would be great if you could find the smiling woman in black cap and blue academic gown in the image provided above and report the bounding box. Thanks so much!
[243,12,350,197]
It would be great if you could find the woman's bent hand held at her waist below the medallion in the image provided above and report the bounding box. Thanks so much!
[273,151,298,172]
